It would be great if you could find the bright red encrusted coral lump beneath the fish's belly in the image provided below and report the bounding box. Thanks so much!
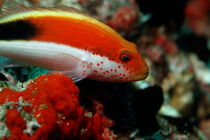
[0,75,115,140]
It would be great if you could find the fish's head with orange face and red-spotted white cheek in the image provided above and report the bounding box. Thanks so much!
[88,41,148,82]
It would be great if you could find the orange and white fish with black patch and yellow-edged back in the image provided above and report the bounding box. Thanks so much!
[0,0,149,82]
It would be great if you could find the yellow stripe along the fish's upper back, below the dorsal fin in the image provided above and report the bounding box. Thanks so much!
[0,9,122,38]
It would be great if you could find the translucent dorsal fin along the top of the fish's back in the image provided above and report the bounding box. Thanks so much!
[0,0,90,17]
